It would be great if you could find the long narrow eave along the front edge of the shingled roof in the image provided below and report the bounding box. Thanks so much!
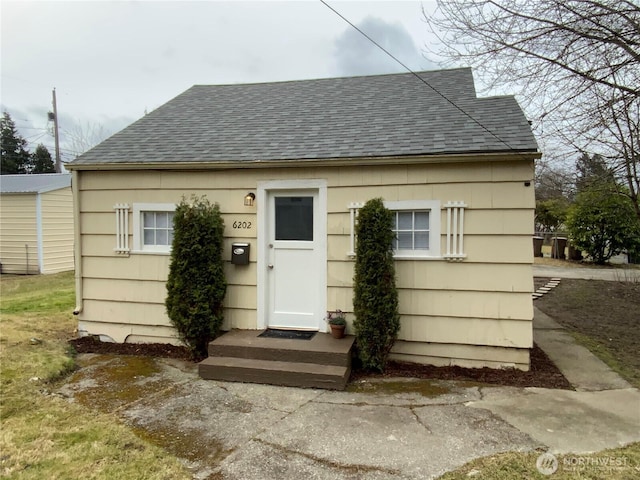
[66,150,542,171]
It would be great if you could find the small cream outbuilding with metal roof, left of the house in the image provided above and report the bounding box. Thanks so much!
[0,173,74,274]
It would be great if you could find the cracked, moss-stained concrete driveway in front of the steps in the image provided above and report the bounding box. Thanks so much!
[57,348,640,480]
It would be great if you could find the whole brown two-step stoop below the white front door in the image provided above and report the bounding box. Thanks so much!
[198,330,355,390]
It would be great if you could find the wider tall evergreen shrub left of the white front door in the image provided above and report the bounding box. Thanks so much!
[165,196,227,358]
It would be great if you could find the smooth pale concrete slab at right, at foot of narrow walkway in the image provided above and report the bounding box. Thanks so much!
[468,388,640,454]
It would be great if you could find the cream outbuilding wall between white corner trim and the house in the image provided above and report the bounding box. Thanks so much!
[40,187,73,273]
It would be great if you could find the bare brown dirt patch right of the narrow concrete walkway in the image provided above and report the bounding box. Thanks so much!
[536,279,640,385]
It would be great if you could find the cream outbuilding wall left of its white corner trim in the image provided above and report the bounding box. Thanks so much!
[0,193,40,274]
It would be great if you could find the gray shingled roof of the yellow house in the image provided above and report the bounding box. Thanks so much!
[71,68,537,167]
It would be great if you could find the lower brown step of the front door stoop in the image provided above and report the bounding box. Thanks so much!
[198,356,351,390]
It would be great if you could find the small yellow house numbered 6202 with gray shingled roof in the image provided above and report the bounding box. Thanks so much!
[67,69,540,369]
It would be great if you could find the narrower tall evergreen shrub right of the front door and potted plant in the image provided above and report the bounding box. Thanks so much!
[353,198,400,371]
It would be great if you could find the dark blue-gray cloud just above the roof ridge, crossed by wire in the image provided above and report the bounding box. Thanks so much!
[333,16,435,76]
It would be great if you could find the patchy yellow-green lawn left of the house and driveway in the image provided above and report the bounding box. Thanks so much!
[0,272,191,480]
